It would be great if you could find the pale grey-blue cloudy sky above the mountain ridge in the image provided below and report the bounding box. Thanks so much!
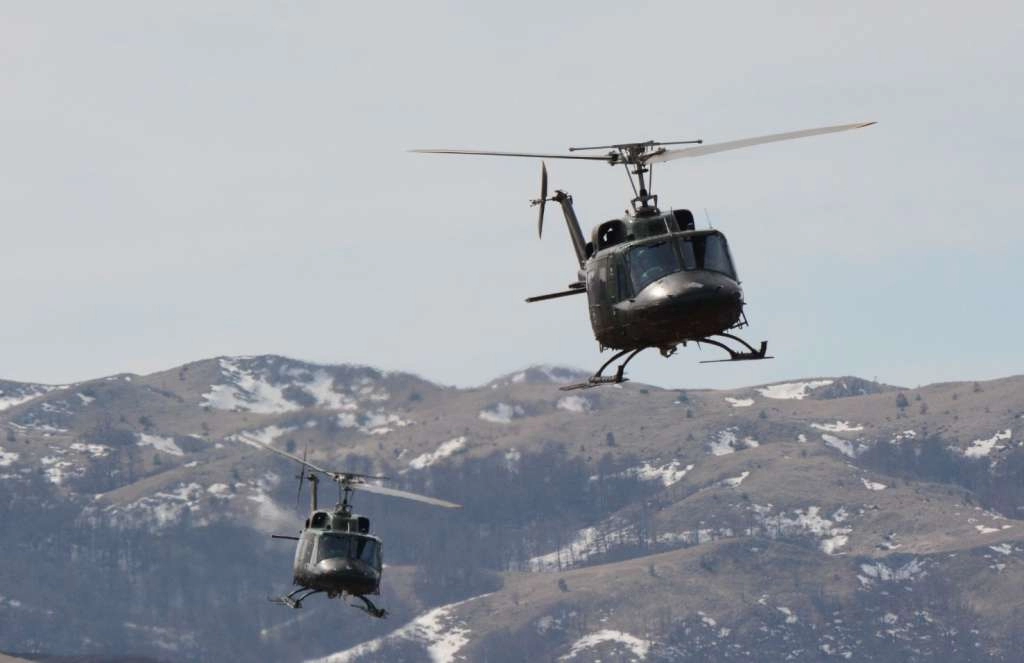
[0,0,1024,388]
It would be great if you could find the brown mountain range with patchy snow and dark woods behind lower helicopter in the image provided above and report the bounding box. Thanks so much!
[0,356,1024,661]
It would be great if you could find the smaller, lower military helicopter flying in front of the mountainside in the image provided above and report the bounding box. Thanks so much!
[253,440,462,618]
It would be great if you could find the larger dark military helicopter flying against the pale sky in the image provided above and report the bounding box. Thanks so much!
[412,122,876,390]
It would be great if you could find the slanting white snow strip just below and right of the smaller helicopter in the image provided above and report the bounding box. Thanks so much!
[309,593,490,663]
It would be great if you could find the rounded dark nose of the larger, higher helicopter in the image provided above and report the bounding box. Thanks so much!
[635,271,743,338]
